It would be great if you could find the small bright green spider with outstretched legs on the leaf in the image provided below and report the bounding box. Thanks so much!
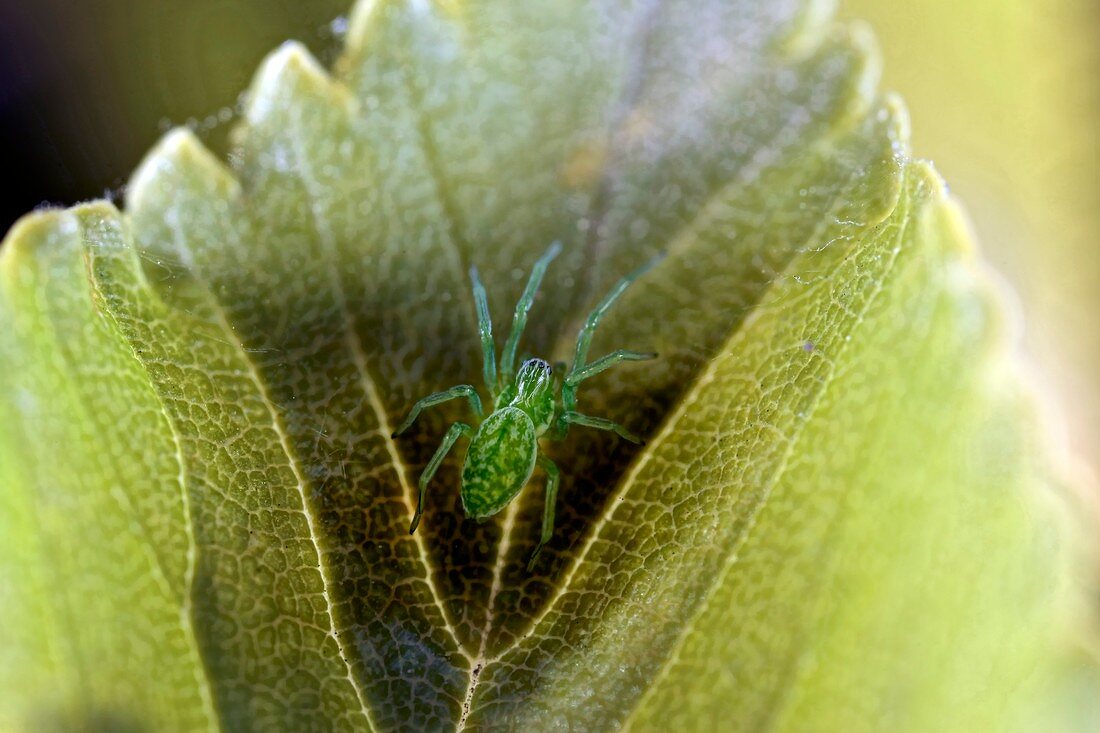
[393,242,661,571]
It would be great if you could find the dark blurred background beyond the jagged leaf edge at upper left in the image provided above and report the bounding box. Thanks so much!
[0,0,351,236]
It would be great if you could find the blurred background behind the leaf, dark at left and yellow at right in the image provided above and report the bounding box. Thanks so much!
[0,0,1100,477]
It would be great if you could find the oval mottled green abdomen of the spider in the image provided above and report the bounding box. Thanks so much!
[461,407,538,519]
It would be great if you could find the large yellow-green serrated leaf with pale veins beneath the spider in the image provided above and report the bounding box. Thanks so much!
[0,0,1071,731]
